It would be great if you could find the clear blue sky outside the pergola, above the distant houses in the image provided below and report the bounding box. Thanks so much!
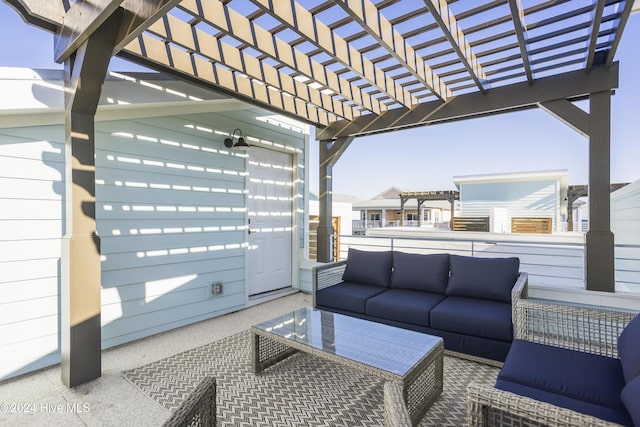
[0,2,640,199]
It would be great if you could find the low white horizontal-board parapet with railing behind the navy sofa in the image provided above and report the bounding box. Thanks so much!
[330,235,640,294]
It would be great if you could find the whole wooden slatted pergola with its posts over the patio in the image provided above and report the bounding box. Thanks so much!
[5,0,634,386]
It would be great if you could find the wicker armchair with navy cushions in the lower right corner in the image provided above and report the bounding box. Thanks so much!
[467,299,640,426]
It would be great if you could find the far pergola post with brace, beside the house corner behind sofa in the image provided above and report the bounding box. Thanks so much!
[317,136,354,262]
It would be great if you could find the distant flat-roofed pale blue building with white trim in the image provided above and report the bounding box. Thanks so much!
[453,170,568,233]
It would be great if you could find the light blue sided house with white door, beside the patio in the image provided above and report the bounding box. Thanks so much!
[0,68,312,379]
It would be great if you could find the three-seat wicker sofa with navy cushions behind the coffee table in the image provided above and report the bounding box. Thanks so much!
[313,248,527,365]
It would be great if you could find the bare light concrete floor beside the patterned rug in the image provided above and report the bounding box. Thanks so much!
[0,292,312,426]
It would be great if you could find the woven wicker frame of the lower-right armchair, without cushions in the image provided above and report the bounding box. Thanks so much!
[467,299,637,426]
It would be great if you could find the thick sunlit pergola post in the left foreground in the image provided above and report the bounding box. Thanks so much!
[60,13,122,387]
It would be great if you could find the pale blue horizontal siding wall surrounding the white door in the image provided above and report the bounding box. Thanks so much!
[0,98,306,379]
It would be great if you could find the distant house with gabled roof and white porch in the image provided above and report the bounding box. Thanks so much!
[353,187,458,234]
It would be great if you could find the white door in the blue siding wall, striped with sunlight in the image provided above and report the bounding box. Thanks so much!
[247,147,293,296]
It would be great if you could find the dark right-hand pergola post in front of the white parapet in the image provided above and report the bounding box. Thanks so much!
[585,91,615,292]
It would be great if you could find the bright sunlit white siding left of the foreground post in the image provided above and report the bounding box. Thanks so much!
[0,126,64,379]
